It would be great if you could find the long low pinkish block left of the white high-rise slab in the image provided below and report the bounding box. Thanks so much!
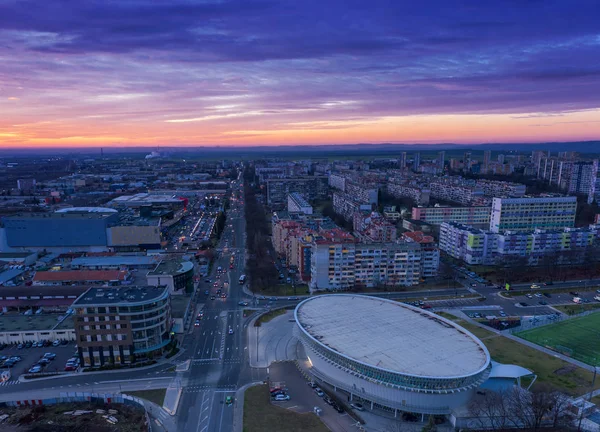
[411,206,492,228]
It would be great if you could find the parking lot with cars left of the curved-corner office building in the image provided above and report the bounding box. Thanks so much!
[0,342,75,381]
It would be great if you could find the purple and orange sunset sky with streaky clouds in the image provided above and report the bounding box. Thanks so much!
[0,0,600,148]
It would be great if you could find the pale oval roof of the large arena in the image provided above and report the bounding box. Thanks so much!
[296,294,490,378]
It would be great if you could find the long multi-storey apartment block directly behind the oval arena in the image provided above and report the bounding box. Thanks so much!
[309,238,421,292]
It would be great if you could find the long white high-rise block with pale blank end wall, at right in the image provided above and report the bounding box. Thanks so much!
[489,196,577,232]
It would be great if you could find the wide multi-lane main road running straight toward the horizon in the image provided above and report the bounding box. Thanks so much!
[177,173,251,432]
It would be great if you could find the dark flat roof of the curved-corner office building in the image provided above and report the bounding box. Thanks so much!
[73,286,169,307]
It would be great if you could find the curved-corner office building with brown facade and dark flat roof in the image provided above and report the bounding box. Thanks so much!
[72,287,172,367]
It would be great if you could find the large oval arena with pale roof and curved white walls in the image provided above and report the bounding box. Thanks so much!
[294,294,491,414]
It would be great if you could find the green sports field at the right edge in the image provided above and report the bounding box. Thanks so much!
[517,313,600,366]
